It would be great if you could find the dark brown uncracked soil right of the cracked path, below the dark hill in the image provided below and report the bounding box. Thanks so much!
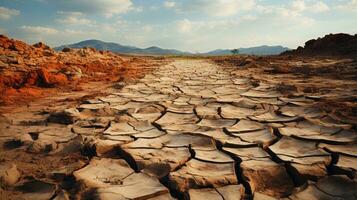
[211,56,357,120]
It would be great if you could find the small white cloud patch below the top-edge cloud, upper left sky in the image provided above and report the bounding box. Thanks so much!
[56,11,96,26]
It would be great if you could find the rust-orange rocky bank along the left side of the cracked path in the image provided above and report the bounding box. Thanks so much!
[0,35,156,103]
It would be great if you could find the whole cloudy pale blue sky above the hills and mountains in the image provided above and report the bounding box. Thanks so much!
[0,0,357,52]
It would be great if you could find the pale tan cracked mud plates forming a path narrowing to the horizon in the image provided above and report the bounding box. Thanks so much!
[0,59,357,200]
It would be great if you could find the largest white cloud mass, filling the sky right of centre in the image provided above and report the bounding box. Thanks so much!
[167,0,320,51]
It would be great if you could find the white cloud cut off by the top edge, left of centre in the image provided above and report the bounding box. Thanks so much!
[51,0,135,17]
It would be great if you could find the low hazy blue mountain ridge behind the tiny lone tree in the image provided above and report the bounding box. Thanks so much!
[204,45,290,55]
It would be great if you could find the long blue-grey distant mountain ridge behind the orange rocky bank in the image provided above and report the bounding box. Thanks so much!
[54,40,190,55]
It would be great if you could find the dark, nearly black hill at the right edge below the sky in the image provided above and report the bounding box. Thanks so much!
[282,33,357,57]
